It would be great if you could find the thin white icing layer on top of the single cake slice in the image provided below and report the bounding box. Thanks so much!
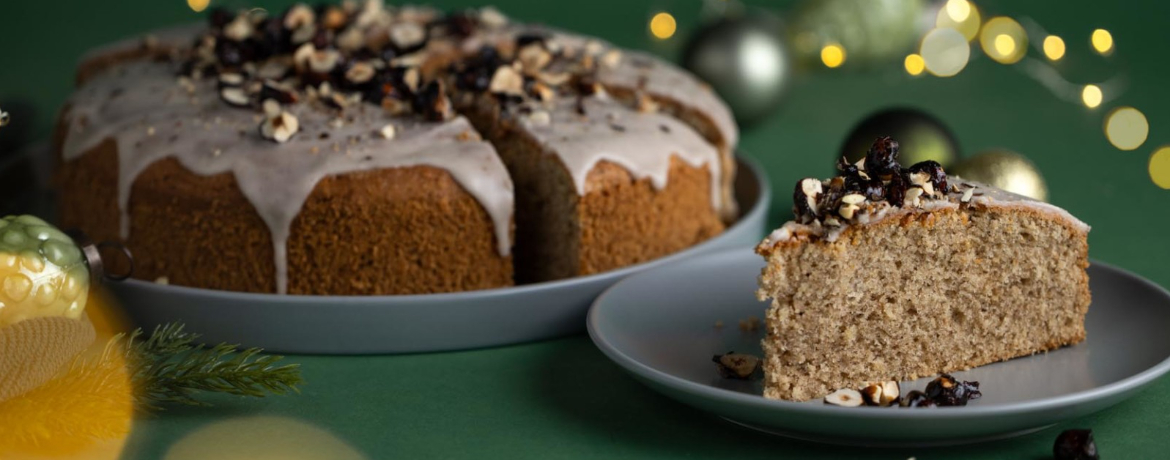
[758,176,1090,250]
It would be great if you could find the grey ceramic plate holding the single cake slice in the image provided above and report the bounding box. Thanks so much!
[589,249,1170,446]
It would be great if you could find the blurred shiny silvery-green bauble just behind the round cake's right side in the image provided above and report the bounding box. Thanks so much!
[682,11,792,124]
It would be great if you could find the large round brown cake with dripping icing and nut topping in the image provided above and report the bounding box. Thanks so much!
[56,1,737,295]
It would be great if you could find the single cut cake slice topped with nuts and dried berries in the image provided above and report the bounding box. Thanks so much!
[756,137,1089,400]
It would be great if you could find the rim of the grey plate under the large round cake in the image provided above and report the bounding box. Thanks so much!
[109,155,772,301]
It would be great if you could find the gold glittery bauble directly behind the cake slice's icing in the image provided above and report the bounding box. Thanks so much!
[947,149,1048,201]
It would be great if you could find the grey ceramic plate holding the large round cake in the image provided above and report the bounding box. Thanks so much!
[110,158,771,353]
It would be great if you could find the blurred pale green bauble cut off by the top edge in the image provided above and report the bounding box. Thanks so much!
[790,0,927,67]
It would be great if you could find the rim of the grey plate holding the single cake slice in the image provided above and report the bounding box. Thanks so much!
[586,249,1170,420]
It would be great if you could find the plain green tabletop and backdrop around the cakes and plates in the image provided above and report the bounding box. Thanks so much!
[0,0,1170,459]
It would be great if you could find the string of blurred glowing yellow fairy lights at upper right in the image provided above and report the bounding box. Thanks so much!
[650,0,1170,190]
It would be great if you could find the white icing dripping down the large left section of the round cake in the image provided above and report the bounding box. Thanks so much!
[62,62,512,294]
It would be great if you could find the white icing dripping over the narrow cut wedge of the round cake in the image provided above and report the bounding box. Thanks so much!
[519,96,723,211]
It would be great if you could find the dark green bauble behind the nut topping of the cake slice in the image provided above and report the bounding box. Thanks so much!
[833,108,958,172]
